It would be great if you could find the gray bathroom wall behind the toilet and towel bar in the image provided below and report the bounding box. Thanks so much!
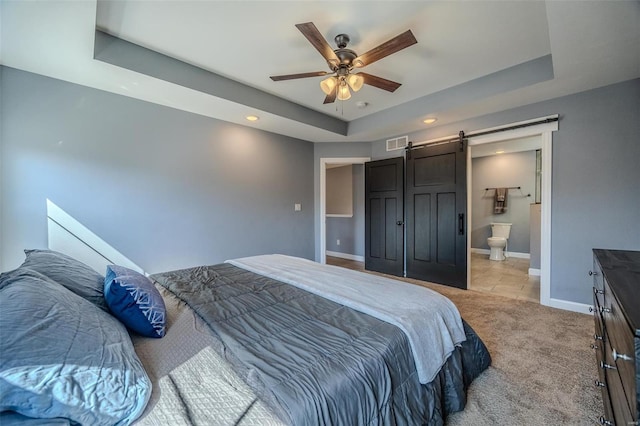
[471,151,536,253]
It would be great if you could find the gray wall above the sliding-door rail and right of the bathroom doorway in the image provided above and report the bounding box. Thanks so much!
[372,79,640,304]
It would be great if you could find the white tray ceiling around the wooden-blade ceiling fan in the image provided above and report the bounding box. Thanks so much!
[0,0,640,142]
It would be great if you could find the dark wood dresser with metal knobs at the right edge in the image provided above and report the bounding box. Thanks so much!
[589,249,640,426]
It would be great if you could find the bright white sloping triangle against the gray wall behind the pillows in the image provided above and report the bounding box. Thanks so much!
[47,199,145,274]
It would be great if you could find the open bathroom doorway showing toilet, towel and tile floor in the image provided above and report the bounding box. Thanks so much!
[469,135,542,303]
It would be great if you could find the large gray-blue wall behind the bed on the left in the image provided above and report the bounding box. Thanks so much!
[0,68,314,272]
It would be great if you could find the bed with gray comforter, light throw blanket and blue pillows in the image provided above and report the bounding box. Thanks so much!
[0,250,491,425]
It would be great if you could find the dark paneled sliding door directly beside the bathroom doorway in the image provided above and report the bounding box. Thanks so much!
[406,142,467,288]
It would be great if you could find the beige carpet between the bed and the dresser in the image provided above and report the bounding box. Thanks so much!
[356,268,603,425]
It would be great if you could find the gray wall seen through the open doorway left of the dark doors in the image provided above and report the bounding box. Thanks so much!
[326,164,364,257]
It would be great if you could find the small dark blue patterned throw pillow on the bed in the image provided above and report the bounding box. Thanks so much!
[104,265,166,338]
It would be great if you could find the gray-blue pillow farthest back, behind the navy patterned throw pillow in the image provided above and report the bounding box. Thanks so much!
[20,250,109,312]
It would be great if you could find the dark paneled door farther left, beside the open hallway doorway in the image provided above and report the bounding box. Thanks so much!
[364,157,404,276]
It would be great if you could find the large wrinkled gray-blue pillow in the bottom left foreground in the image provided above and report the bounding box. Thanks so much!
[0,268,152,425]
